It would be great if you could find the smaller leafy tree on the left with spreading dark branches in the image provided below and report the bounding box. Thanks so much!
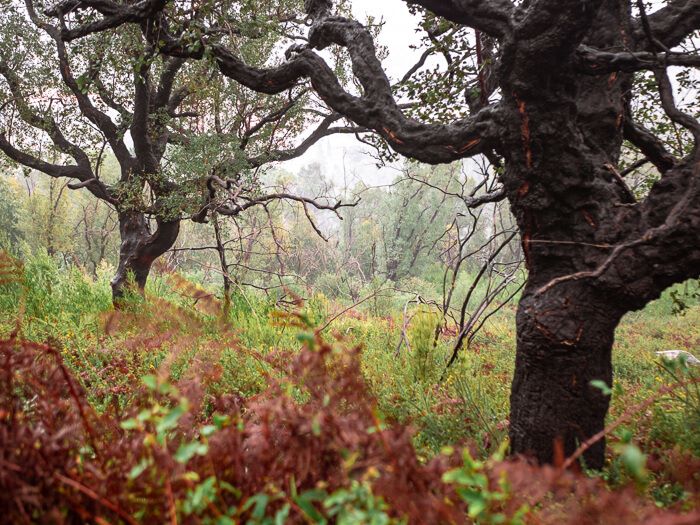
[0,0,350,298]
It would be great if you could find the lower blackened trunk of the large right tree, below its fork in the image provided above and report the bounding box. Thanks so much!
[510,283,622,468]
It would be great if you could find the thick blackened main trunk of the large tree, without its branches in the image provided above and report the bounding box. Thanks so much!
[492,2,637,468]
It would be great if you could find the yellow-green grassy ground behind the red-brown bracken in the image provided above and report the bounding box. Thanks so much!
[0,252,700,516]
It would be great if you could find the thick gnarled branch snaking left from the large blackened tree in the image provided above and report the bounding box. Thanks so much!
[45,0,500,164]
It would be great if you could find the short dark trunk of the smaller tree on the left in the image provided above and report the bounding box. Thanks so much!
[112,212,180,304]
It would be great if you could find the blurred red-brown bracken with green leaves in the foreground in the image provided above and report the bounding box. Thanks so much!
[0,326,699,524]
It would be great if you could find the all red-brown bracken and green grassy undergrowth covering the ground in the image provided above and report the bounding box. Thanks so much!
[0,252,700,524]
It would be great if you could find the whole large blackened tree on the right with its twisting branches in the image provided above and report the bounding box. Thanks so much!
[52,0,700,468]
